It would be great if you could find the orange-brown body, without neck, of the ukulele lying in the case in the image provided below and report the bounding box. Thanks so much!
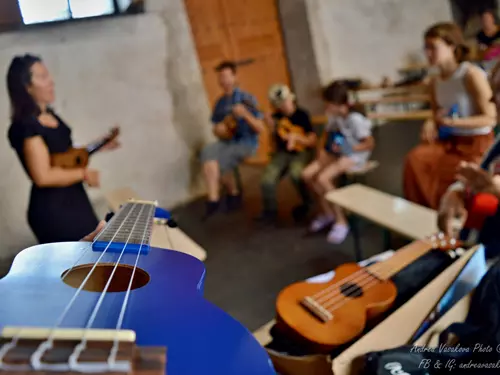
[276,263,397,353]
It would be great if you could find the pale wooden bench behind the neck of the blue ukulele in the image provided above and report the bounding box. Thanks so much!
[105,188,207,261]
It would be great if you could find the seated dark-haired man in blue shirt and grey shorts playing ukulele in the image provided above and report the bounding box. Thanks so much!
[201,61,264,219]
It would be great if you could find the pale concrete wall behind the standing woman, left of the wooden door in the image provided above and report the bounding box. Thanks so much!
[0,0,210,257]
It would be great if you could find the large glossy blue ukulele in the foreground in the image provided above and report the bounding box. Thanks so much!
[0,201,276,375]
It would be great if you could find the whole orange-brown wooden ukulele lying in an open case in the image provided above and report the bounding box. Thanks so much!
[276,234,463,354]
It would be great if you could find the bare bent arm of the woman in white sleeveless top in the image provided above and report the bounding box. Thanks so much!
[443,66,497,128]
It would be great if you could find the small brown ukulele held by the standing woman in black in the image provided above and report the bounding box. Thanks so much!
[50,128,120,168]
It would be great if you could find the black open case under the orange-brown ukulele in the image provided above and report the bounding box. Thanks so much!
[266,250,453,358]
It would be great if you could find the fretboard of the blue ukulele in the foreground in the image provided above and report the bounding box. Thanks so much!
[92,202,155,254]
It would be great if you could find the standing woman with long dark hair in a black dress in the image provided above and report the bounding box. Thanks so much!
[7,55,117,243]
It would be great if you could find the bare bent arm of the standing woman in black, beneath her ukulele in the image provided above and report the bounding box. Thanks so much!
[23,136,85,187]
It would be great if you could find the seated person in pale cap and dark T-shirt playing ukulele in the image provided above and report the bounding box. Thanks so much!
[256,84,316,224]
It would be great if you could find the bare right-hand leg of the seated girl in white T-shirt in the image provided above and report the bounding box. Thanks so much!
[318,157,355,224]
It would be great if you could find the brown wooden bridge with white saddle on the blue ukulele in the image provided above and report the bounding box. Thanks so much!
[0,327,166,375]
